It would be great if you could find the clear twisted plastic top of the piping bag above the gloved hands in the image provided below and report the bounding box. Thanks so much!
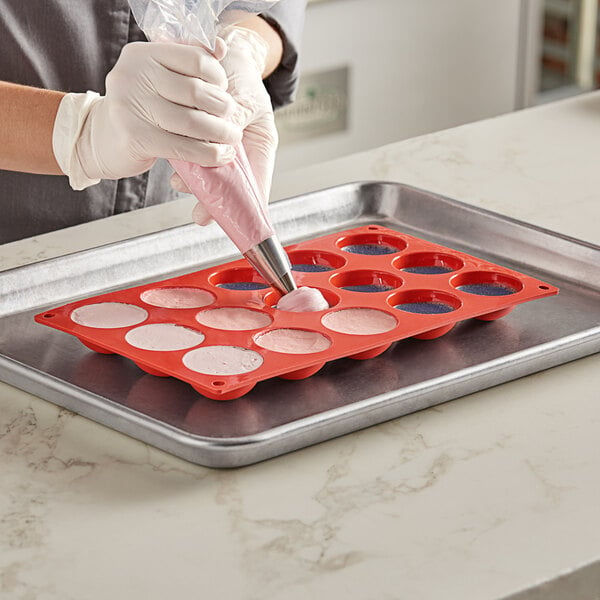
[129,0,279,50]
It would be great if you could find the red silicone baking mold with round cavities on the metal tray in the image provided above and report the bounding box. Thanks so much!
[35,225,558,400]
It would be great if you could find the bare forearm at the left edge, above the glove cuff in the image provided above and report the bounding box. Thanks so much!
[0,81,65,175]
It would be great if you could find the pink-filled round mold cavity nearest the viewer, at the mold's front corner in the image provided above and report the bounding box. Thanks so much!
[182,346,263,376]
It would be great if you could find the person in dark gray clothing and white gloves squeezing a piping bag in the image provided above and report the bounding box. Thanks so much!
[0,0,305,243]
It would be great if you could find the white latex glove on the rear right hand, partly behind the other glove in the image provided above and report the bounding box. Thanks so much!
[171,27,278,225]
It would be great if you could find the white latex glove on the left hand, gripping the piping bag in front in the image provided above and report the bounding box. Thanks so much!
[52,42,242,190]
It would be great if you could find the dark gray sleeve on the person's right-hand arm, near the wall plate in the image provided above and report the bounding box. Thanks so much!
[260,0,306,108]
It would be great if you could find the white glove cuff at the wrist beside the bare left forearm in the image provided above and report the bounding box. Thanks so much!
[52,92,101,190]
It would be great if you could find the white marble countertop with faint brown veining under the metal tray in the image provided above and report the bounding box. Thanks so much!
[0,93,600,600]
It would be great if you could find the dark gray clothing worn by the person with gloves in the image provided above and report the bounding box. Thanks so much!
[0,0,305,244]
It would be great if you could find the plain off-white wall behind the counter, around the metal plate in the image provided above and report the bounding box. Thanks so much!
[277,0,522,172]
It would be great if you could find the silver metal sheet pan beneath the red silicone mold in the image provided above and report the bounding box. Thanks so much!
[0,182,600,467]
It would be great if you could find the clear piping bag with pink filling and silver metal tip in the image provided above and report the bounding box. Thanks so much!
[129,0,297,295]
